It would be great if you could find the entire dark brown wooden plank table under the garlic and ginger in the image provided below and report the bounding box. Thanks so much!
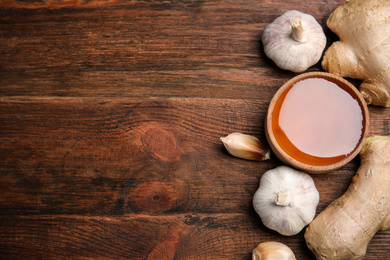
[0,0,390,260]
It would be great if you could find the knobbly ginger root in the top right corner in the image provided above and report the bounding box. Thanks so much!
[322,0,390,107]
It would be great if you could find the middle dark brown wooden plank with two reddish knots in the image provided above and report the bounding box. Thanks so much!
[0,97,374,215]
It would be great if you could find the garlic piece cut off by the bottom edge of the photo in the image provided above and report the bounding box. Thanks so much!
[252,241,296,260]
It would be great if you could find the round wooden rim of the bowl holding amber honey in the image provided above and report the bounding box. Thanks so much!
[265,72,369,174]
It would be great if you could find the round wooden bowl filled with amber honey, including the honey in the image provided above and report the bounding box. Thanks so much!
[266,73,368,172]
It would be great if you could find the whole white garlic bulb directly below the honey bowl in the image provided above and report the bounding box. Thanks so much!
[253,166,320,236]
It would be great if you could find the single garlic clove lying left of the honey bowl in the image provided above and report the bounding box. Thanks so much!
[221,133,271,161]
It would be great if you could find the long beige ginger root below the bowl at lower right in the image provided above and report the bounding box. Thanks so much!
[305,136,390,260]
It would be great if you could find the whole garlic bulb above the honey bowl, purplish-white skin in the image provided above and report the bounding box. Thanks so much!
[261,10,326,73]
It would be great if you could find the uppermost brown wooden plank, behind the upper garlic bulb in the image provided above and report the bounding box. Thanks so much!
[0,0,343,99]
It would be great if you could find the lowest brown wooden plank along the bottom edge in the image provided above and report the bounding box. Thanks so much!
[0,214,389,260]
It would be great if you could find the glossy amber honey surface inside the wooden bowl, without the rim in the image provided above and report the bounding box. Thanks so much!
[272,78,363,165]
